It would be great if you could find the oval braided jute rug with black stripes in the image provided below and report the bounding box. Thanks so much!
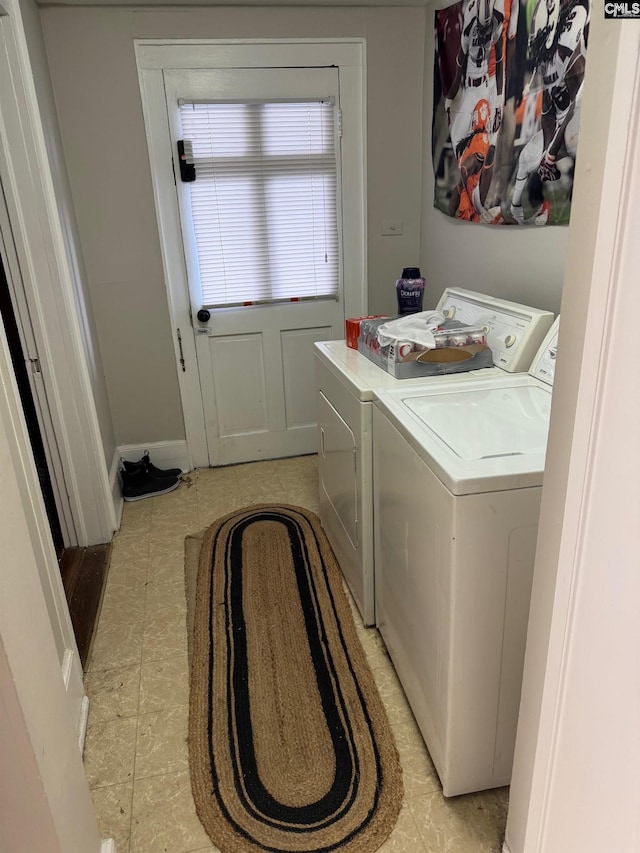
[189,505,402,853]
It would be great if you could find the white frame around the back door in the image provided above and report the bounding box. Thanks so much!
[135,38,367,468]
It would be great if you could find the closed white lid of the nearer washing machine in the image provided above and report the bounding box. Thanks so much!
[404,386,551,461]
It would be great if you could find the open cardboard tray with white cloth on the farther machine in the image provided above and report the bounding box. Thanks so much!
[358,317,493,379]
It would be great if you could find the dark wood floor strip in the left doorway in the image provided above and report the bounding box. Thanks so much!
[59,545,111,669]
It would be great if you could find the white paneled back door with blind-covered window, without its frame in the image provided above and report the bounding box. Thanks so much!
[164,68,345,465]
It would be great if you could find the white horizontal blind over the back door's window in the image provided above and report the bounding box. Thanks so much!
[180,99,339,308]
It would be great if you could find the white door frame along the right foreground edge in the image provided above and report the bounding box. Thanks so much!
[503,15,640,853]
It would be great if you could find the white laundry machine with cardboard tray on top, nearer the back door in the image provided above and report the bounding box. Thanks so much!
[315,288,553,625]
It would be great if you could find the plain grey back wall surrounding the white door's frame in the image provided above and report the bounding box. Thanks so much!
[41,7,424,444]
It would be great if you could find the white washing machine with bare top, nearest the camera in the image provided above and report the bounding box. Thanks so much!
[373,321,558,796]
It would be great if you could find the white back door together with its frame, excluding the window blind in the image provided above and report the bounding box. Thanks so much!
[136,39,367,467]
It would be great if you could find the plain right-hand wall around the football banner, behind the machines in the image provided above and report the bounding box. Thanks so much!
[420,3,569,313]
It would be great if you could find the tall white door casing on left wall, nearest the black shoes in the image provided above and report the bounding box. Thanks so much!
[0,0,118,545]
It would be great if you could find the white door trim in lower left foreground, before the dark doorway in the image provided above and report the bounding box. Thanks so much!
[0,328,106,853]
